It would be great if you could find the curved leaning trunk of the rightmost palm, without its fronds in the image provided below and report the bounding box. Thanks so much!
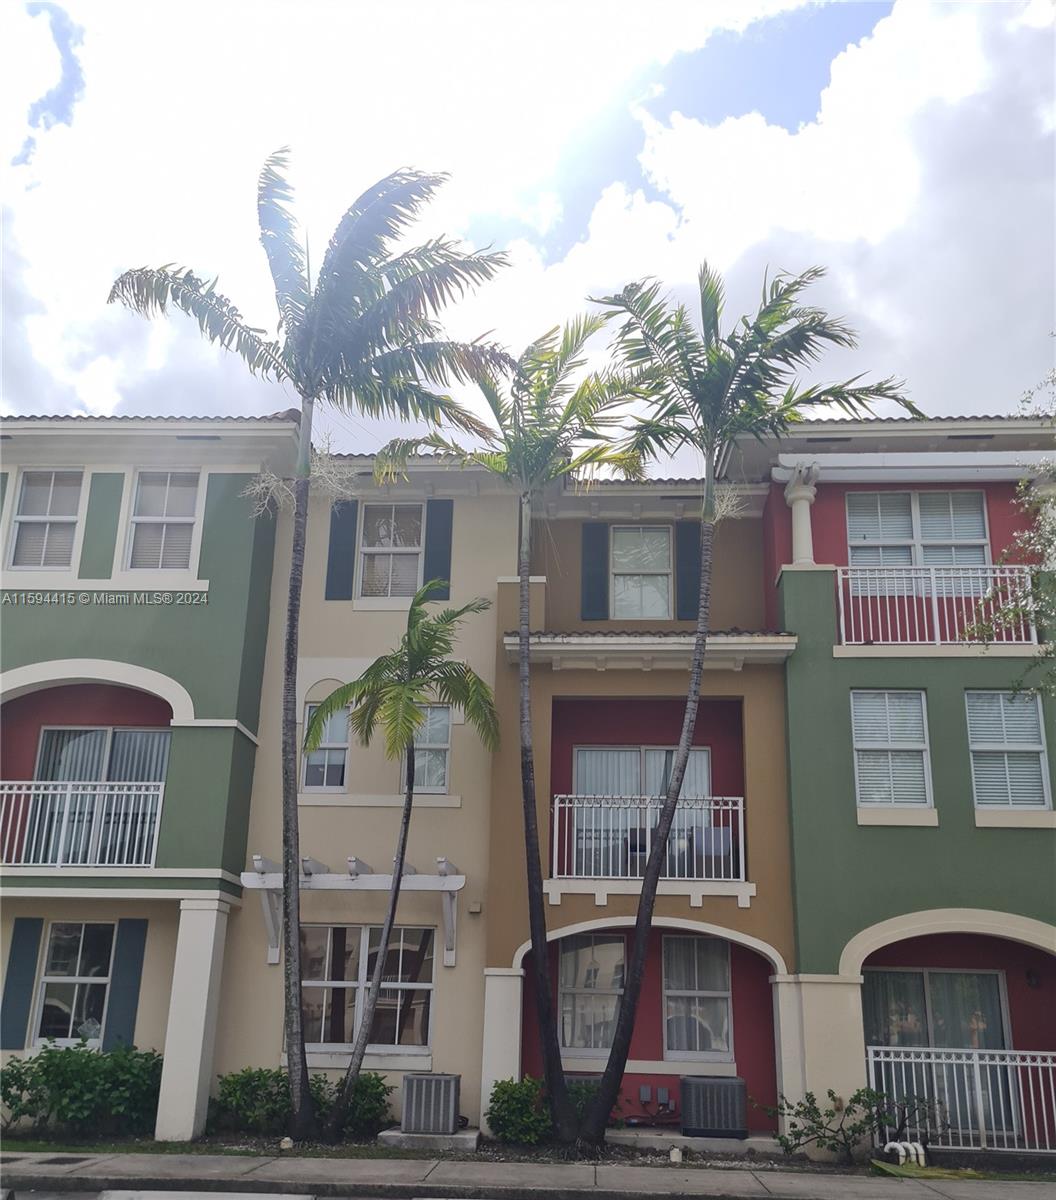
[580,468,715,1146]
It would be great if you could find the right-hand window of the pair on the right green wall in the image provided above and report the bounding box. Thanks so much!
[965,691,1050,809]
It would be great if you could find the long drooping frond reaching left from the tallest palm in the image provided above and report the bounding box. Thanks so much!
[107,263,293,379]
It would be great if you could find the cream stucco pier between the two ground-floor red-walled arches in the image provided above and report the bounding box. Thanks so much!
[770,974,866,1100]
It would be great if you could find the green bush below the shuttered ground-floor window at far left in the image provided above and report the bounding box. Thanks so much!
[0,1043,162,1134]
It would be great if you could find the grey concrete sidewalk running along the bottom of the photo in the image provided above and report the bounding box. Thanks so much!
[2,1151,1056,1200]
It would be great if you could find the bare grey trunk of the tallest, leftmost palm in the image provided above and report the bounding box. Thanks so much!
[282,397,316,1141]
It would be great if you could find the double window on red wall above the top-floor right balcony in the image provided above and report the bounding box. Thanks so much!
[847,492,989,566]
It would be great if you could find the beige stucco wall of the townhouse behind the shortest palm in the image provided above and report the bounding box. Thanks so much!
[216,473,517,1123]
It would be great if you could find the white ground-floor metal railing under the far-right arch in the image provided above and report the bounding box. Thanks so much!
[866,1046,1056,1153]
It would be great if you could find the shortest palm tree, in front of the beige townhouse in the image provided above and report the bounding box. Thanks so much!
[305,580,499,1136]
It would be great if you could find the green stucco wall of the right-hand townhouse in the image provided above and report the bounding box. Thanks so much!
[780,571,1056,974]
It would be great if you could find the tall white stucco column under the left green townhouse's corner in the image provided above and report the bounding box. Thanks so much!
[155,900,230,1141]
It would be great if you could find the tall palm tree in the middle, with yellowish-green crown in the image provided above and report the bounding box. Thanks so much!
[377,316,642,1142]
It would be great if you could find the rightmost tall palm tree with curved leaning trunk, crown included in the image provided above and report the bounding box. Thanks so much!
[581,263,919,1144]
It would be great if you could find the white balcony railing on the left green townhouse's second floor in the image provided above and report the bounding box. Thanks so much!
[0,781,164,866]
